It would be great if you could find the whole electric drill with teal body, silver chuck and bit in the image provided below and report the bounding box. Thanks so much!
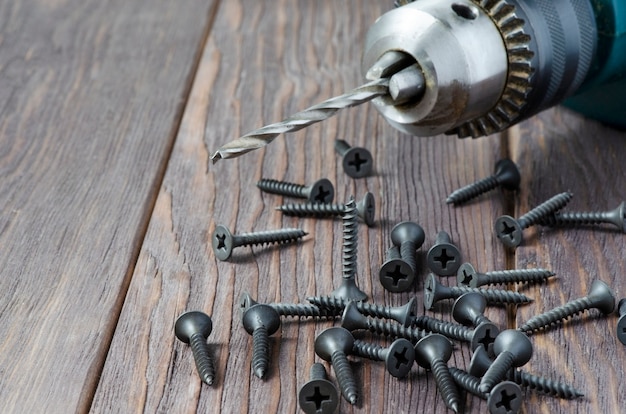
[211,0,626,162]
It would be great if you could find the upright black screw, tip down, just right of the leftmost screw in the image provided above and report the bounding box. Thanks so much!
[241,303,280,379]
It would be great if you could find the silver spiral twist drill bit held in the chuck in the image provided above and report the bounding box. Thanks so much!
[211,78,389,163]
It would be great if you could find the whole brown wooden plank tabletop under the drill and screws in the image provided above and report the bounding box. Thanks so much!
[0,0,626,413]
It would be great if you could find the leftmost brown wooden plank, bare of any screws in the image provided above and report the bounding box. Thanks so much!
[0,1,216,412]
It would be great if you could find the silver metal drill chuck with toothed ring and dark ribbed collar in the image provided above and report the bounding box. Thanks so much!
[362,0,597,137]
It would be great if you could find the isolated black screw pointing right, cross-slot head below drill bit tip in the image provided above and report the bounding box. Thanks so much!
[211,226,308,260]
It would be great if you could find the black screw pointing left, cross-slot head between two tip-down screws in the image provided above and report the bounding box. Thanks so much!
[352,338,415,378]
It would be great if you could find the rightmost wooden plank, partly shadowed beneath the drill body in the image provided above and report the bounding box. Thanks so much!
[511,108,626,413]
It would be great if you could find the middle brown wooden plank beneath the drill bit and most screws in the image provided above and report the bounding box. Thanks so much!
[92,1,506,413]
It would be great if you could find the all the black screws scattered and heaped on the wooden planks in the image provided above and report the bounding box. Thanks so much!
[175,154,626,414]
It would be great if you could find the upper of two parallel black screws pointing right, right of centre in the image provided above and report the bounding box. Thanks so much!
[456,263,555,287]
